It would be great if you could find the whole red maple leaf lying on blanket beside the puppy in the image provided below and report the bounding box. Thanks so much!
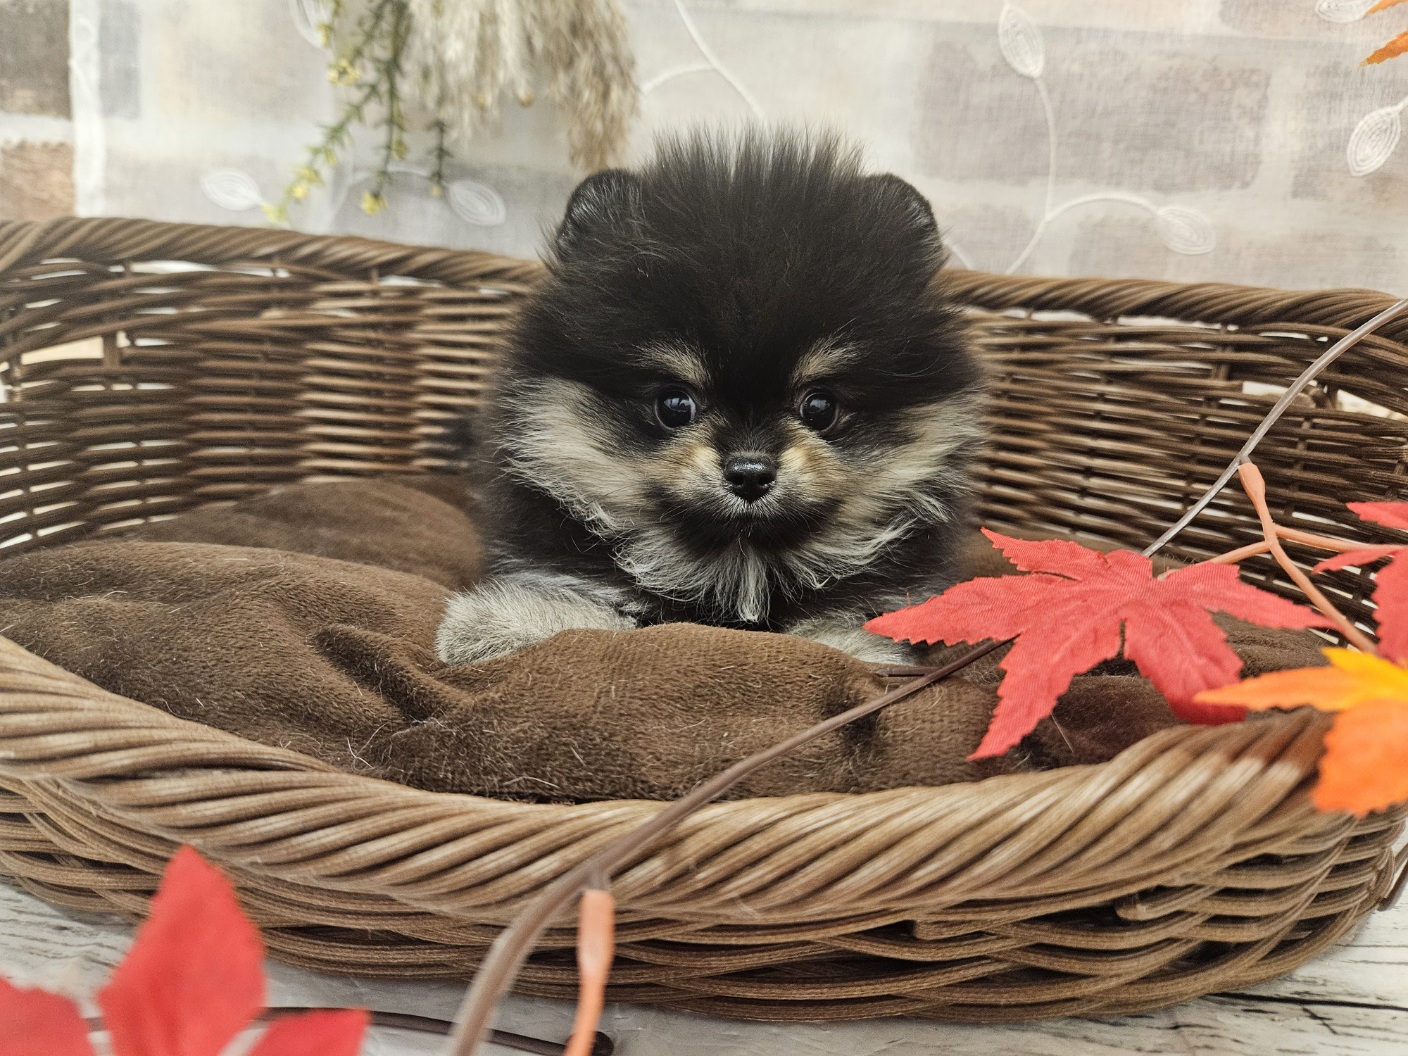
[866,528,1329,759]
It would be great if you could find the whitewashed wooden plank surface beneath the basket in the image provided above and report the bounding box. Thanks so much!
[0,883,1408,1056]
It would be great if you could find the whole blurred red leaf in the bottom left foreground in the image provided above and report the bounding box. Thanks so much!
[0,848,367,1056]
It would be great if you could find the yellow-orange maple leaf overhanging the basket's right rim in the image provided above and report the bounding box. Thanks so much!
[1194,649,1408,818]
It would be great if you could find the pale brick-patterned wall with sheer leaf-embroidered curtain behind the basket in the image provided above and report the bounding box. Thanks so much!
[0,0,1408,293]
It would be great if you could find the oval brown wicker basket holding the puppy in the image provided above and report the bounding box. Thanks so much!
[0,220,1408,1019]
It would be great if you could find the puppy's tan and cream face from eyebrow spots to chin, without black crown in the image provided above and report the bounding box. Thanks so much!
[511,334,974,553]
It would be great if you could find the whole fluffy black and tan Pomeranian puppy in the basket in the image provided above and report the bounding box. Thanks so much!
[436,132,980,663]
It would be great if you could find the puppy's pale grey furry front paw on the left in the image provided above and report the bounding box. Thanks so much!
[435,579,635,663]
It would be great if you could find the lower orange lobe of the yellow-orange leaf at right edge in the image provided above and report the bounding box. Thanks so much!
[1311,697,1408,818]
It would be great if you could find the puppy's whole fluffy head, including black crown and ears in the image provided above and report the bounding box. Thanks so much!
[496,136,977,622]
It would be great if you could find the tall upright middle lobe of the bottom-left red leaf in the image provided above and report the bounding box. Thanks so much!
[99,848,265,1056]
